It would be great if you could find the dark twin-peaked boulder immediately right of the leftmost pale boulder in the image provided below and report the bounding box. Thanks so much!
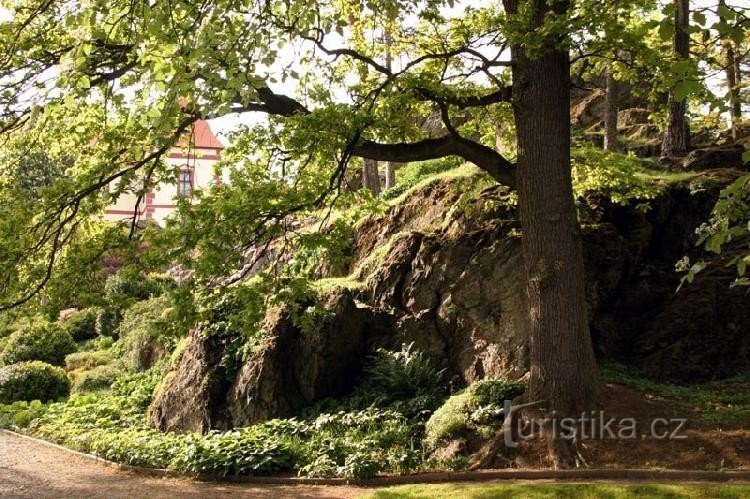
[227,289,368,426]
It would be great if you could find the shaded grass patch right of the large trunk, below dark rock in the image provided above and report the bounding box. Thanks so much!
[601,363,750,423]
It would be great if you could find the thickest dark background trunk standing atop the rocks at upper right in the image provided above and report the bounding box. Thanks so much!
[661,0,690,159]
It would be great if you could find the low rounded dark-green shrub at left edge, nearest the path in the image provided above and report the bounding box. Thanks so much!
[0,361,70,404]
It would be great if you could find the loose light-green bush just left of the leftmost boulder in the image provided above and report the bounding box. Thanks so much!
[115,296,174,372]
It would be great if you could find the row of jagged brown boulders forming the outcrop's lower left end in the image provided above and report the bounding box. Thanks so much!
[149,289,382,432]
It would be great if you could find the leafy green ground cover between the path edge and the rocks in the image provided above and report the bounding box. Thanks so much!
[0,349,450,478]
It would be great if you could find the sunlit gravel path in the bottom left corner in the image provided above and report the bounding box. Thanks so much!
[0,432,367,499]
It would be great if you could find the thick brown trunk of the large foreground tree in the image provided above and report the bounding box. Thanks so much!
[504,0,599,468]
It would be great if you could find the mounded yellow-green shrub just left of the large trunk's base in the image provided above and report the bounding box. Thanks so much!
[424,379,524,449]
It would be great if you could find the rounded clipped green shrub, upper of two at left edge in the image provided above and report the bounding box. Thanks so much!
[0,322,76,366]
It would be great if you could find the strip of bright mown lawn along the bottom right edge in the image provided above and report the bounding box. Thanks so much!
[362,483,750,499]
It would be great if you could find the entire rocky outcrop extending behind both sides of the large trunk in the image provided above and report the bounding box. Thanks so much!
[151,172,750,431]
